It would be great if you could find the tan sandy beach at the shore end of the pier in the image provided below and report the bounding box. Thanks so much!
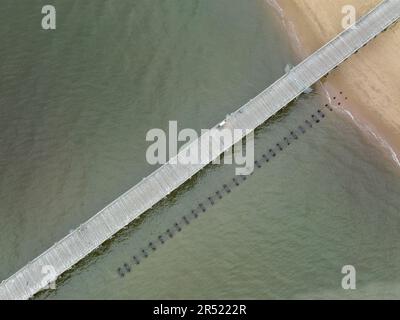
[267,0,400,166]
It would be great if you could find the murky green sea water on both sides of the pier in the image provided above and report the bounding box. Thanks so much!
[0,0,400,299]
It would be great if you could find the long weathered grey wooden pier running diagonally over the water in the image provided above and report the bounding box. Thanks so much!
[0,0,400,299]
